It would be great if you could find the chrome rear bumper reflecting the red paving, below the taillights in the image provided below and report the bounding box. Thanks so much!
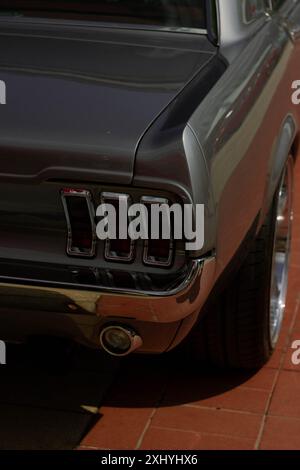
[0,257,215,352]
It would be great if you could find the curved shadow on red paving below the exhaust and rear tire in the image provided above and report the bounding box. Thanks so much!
[98,353,258,408]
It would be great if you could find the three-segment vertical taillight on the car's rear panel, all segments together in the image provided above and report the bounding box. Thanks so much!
[61,188,174,267]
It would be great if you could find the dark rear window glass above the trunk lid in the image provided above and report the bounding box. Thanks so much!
[0,0,206,29]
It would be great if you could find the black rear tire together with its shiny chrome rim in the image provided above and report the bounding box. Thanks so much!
[187,157,293,369]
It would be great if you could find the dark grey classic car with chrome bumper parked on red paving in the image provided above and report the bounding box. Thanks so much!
[0,0,300,368]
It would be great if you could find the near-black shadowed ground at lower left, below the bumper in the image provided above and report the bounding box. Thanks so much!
[0,338,118,449]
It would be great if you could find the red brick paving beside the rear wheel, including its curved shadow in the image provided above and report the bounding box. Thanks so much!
[79,160,300,450]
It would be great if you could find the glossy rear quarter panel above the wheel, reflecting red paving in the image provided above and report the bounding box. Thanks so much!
[189,14,299,275]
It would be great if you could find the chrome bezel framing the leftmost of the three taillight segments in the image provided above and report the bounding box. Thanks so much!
[60,188,97,258]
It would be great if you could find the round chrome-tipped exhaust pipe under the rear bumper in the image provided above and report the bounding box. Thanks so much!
[99,325,143,357]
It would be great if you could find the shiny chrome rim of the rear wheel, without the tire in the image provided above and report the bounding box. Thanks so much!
[269,158,293,348]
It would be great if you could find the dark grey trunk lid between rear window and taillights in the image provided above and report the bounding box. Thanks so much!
[0,19,215,184]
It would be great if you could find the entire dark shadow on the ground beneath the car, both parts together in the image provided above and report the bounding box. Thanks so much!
[0,338,253,449]
